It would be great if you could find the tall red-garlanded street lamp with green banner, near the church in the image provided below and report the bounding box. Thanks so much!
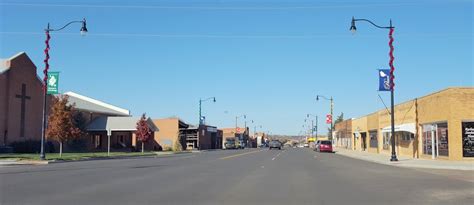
[40,18,87,160]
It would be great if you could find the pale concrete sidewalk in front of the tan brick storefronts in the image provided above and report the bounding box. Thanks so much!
[335,148,474,171]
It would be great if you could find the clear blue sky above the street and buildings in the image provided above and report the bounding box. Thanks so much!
[0,0,474,134]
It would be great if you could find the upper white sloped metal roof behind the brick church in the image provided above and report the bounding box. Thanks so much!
[64,92,130,116]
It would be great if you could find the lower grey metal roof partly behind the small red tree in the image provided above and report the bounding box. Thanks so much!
[86,116,159,132]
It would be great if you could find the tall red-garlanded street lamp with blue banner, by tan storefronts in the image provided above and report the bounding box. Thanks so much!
[349,17,398,161]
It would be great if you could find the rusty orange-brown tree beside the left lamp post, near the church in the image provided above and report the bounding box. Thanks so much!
[46,95,83,157]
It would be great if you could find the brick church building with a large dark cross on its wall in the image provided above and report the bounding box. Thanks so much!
[0,52,47,146]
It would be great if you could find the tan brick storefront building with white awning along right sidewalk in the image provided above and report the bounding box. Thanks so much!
[348,87,474,160]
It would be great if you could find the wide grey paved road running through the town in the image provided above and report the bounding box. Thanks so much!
[0,148,474,205]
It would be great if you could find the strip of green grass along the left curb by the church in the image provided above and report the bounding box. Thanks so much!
[0,152,157,161]
